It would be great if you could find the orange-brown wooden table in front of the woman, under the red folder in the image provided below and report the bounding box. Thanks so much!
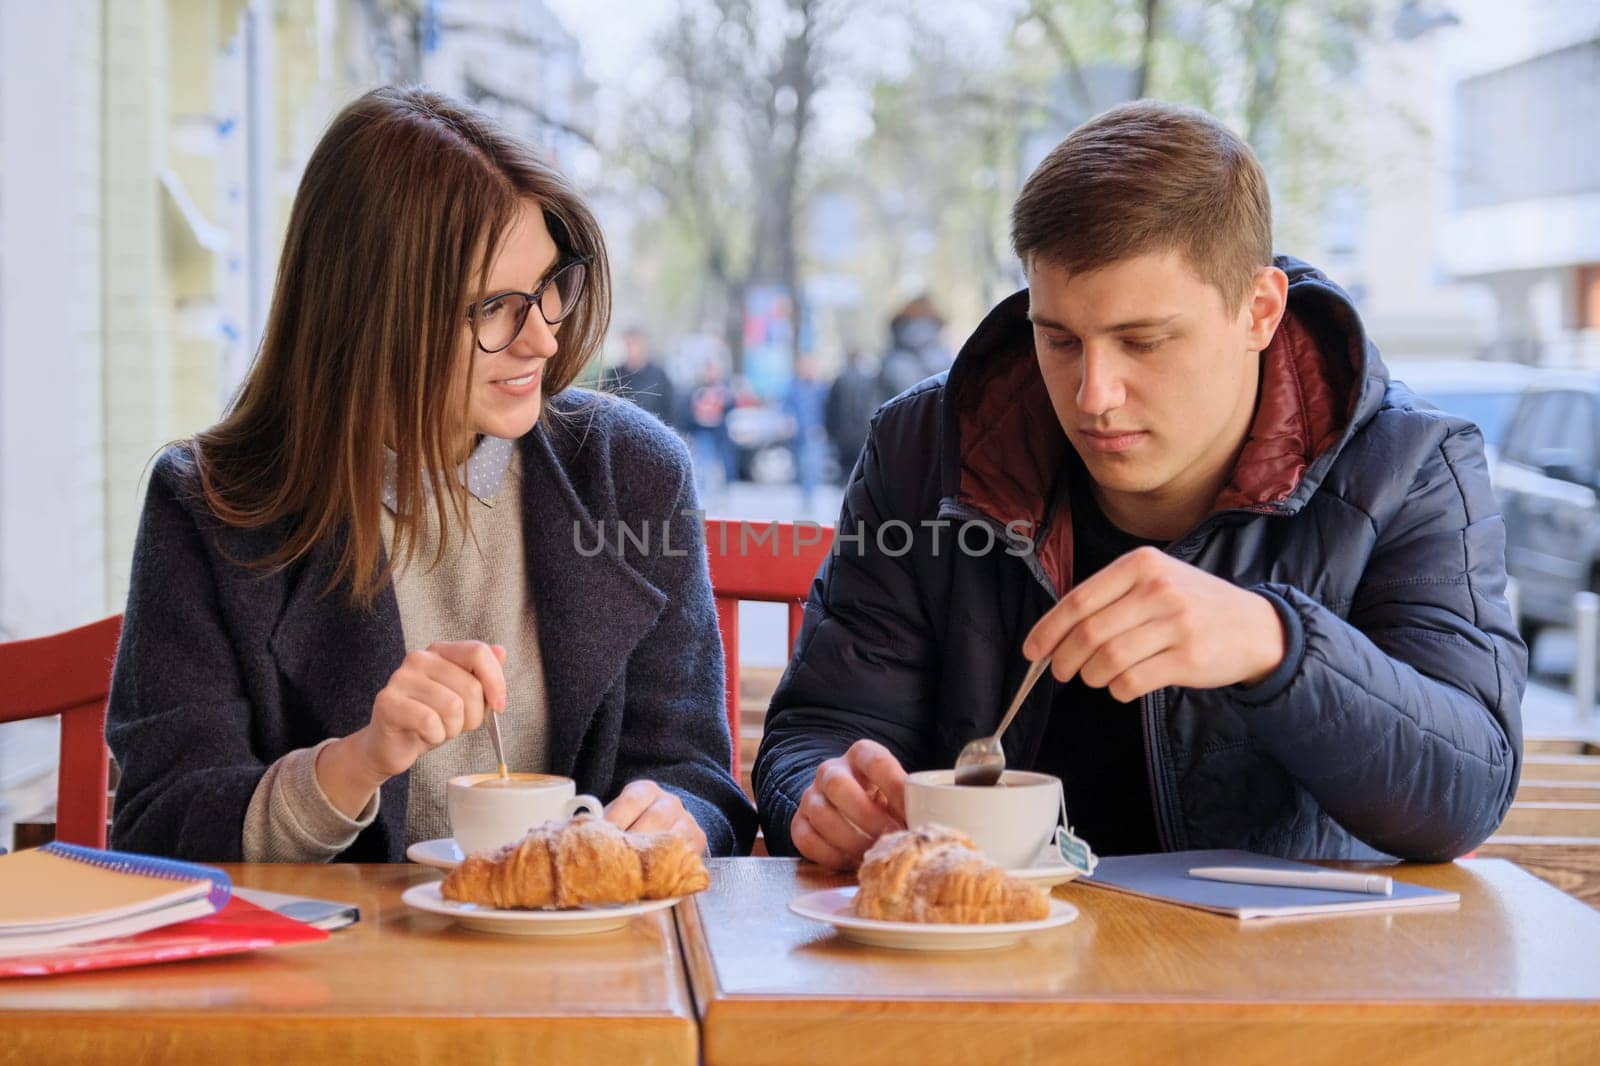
[0,866,698,1066]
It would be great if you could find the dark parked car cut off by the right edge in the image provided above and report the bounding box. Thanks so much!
[1494,371,1600,643]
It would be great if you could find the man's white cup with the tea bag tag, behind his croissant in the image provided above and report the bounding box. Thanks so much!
[906,770,1061,869]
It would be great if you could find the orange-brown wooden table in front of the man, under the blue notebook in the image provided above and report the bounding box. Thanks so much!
[678,860,1600,1066]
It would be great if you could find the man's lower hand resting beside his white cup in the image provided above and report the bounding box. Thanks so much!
[789,739,906,869]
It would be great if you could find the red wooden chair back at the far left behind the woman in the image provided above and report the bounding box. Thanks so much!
[0,615,122,848]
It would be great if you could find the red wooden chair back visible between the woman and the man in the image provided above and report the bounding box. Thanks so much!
[706,519,834,778]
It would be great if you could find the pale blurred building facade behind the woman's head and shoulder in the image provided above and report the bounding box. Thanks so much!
[0,0,581,845]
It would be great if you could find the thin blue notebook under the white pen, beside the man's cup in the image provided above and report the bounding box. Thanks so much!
[1078,850,1461,919]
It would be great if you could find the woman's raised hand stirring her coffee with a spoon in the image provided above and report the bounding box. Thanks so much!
[317,640,506,818]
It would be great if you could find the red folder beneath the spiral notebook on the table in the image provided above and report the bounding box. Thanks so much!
[0,896,328,978]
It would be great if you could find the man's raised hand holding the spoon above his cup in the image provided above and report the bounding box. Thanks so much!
[1022,547,1286,703]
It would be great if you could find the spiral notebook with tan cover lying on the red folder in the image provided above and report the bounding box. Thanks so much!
[0,842,232,959]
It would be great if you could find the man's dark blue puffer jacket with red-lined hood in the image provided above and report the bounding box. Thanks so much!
[755,259,1526,861]
